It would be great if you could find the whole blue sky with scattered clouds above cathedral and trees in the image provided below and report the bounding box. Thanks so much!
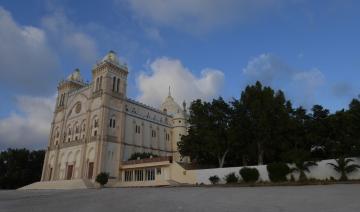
[0,0,360,150]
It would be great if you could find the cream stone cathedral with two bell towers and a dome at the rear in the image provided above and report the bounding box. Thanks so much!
[40,51,191,188]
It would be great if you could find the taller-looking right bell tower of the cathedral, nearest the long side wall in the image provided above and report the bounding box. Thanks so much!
[91,51,128,177]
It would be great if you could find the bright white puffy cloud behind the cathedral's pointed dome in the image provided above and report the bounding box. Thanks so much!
[137,57,224,106]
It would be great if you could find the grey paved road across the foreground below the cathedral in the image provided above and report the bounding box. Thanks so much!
[0,185,360,212]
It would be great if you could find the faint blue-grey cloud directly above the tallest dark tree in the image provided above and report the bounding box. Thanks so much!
[243,54,325,108]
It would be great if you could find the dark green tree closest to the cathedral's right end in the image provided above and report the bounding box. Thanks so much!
[178,97,233,167]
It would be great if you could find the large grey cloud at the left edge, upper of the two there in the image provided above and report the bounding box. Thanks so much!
[0,7,59,94]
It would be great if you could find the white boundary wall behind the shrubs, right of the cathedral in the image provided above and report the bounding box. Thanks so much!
[192,158,360,184]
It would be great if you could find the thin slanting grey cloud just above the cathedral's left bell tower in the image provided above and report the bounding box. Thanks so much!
[42,11,98,63]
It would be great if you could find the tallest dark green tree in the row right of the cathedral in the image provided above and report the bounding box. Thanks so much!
[238,82,291,164]
